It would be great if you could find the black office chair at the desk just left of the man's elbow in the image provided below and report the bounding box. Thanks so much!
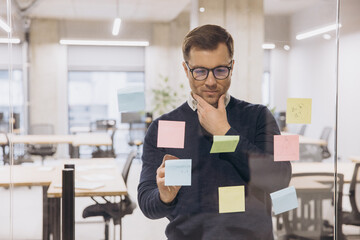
[83,151,136,240]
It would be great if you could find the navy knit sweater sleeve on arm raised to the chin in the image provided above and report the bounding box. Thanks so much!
[220,107,291,193]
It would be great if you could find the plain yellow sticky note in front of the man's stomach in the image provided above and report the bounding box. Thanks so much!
[219,186,245,213]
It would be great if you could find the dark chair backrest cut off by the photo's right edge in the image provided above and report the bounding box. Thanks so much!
[349,163,360,219]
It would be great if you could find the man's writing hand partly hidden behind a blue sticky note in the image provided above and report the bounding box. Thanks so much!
[156,154,181,203]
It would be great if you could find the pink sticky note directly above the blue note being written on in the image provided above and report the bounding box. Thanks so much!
[157,120,185,148]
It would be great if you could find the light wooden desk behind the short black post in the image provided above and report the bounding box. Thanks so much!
[0,158,127,240]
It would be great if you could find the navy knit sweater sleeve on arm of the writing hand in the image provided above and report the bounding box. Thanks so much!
[138,122,177,219]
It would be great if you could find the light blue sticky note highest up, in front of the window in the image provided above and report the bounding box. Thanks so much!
[117,87,145,112]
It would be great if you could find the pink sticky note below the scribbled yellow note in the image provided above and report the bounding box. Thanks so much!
[274,135,299,161]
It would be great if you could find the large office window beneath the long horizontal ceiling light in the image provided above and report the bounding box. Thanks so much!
[69,71,144,129]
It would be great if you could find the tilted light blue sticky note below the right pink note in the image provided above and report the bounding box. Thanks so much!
[270,186,298,215]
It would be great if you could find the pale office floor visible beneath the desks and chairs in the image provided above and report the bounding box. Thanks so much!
[0,155,360,240]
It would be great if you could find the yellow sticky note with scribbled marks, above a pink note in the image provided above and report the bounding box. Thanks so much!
[286,98,312,124]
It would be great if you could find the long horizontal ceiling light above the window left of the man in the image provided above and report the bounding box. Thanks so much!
[60,39,149,47]
